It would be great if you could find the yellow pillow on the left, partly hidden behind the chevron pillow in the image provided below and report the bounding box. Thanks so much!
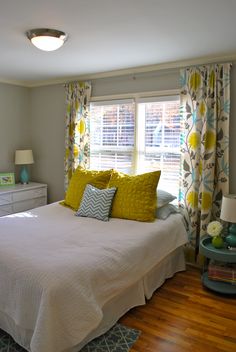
[61,166,112,210]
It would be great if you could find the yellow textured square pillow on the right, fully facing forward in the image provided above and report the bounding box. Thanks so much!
[108,171,161,221]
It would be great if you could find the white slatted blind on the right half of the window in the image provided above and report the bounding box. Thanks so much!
[137,97,180,196]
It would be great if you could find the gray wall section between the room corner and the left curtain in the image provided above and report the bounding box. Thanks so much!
[30,84,65,202]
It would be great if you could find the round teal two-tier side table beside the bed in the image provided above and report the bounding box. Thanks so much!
[199,236,236,295]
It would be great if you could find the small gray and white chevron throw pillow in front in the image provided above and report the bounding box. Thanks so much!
[75,185,116,221]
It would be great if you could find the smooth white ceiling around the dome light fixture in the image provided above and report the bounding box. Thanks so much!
[0,0,236,86]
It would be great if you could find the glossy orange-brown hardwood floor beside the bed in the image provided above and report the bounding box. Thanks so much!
[120,268,236,352]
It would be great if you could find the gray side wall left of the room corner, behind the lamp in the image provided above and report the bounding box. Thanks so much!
[0,83,32,178]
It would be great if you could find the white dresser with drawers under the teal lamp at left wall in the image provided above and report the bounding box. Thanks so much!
[0,182,47,216]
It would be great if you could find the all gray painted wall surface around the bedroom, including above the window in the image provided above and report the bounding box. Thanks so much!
[0,63,236,202]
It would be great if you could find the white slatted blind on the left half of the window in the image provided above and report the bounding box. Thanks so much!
[90,100,135,173]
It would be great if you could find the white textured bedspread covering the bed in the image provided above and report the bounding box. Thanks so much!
[0,203,187,352]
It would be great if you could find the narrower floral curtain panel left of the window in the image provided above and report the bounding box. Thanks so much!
[64,82,91,190]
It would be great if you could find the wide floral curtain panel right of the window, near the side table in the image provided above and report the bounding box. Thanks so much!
[179,64,231,256]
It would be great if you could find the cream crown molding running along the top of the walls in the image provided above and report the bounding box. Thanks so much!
[0,53,236,88]
